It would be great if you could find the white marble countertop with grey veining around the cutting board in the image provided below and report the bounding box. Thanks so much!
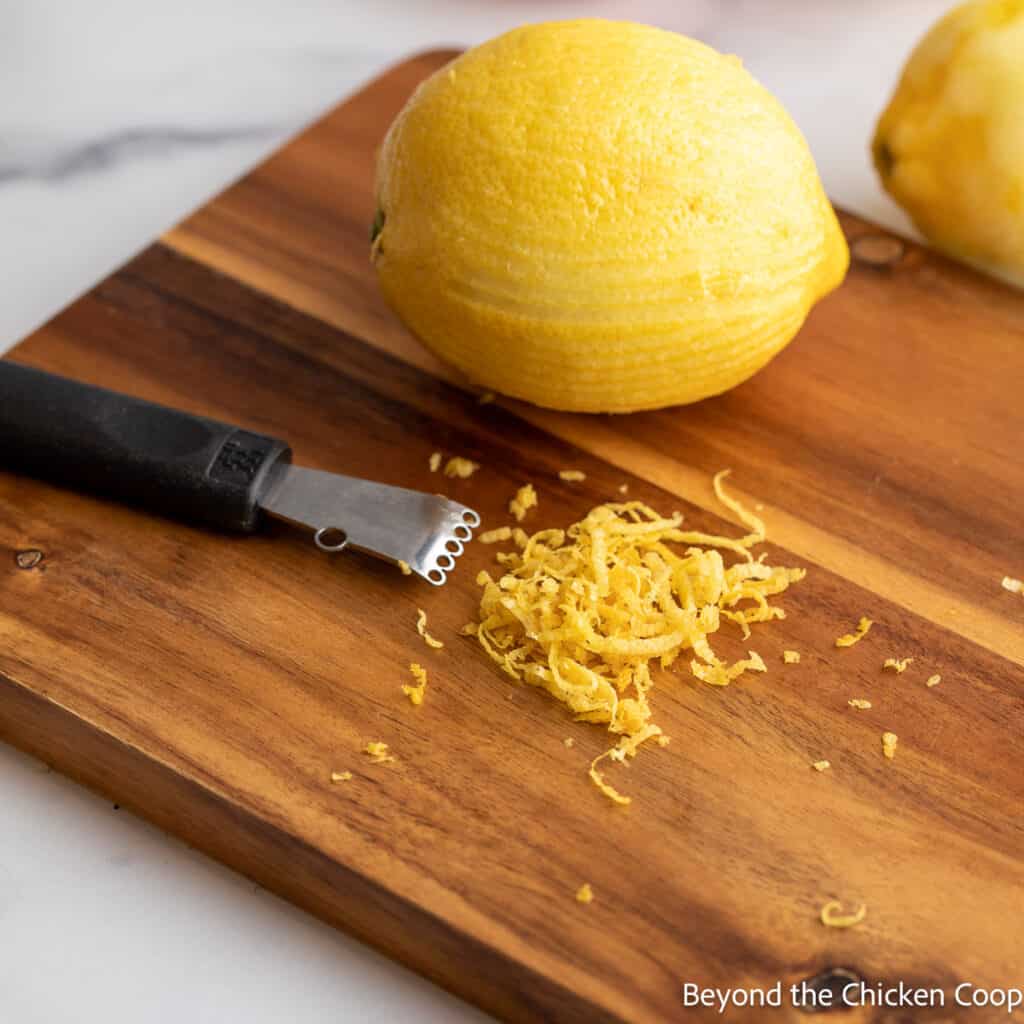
[0,0,949,1024]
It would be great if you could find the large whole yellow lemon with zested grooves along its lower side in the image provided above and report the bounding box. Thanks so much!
[372,19,849,412]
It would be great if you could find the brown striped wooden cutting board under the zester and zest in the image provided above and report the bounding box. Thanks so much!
[0,53,1024,1024]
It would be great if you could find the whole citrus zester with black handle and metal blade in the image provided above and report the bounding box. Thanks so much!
[0,360,480,587]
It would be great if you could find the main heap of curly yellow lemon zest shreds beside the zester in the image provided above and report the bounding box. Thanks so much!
[468,473,805,804]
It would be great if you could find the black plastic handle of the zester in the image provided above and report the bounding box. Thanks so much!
[0,359,292,532]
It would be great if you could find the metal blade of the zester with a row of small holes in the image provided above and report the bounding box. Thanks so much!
[260,466,480,587]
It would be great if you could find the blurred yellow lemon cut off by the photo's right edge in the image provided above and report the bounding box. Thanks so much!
[872,0,1024,285]
